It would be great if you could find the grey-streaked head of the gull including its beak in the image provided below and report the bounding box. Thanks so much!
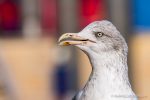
[58,20,127,54]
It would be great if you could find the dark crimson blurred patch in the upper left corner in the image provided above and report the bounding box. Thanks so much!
[0,0,20,31]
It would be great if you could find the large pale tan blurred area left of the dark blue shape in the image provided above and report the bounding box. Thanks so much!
[0,38,55,100]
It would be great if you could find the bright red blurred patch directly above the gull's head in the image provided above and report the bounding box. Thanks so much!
[80,0,107,28]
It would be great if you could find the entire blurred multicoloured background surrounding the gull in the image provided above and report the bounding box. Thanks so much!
[0,0,150,100]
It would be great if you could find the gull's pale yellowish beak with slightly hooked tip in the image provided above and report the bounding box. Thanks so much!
[58,33,95,46]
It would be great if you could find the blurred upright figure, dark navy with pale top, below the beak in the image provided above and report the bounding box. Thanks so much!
[54,48,76,100]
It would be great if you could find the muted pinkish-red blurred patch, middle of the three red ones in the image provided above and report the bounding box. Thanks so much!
[40,0,57,35]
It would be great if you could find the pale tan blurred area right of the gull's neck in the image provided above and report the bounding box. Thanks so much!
[129,34,150,100]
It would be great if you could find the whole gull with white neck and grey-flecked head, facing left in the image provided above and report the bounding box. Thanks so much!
[59,20,137,100]
